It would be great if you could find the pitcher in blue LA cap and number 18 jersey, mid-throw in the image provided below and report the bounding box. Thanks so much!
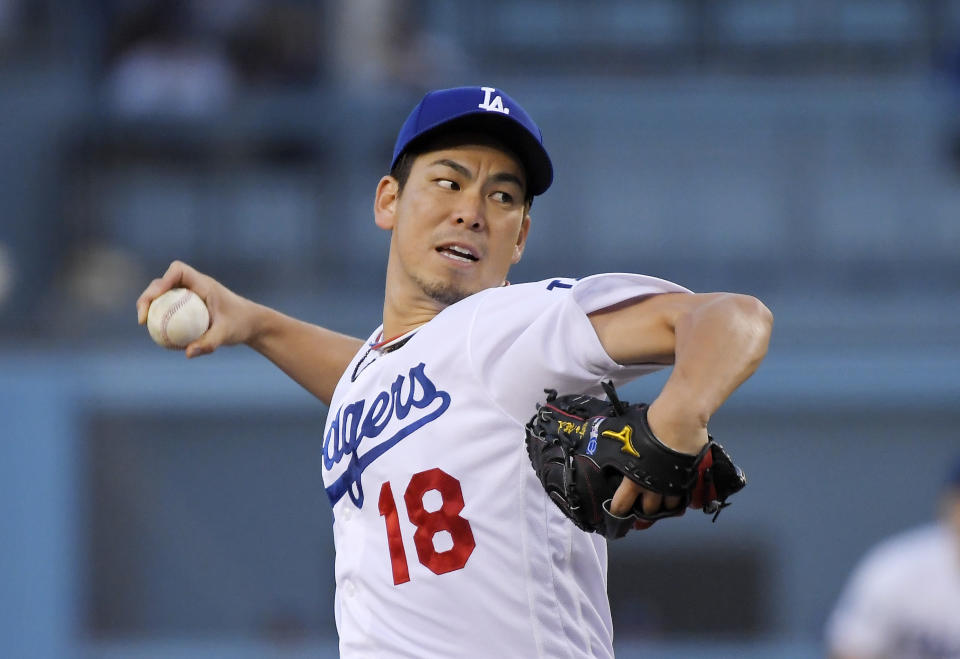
[137,87,772,658]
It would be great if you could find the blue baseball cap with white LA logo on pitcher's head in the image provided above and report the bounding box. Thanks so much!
[390,87,553,195]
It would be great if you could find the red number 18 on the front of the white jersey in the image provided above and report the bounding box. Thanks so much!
[380,469,476,586]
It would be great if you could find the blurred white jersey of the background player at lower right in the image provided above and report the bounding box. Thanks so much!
[827,525,960,659]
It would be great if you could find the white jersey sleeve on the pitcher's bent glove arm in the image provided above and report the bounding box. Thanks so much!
[467,274,690,423]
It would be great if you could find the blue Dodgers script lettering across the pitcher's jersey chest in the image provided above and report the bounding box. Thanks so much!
[323,362,450,508]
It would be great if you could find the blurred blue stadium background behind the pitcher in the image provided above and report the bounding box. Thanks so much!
[0,0,960,658]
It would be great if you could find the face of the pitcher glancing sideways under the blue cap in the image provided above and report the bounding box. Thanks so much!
[375,144,530,306]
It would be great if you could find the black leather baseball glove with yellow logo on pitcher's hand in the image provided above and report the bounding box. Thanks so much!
[526,382,747,540]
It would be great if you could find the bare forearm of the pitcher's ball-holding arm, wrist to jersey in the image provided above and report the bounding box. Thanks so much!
[246,304,363,405]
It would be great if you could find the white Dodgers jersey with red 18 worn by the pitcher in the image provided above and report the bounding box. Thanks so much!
[323,274,689,659]
